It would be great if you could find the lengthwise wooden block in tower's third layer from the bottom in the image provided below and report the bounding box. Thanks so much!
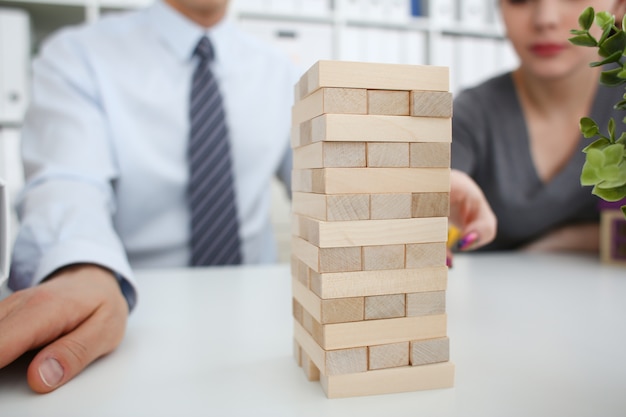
[320,314,447,350]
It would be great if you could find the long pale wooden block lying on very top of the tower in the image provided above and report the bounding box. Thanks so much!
[295,60,450,101]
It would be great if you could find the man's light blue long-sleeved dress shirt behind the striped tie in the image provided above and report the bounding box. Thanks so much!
[10,1,299,306]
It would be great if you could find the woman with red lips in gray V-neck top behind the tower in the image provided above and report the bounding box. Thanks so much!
[452,0,626,252]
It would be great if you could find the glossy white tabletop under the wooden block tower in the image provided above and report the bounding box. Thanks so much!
[0,254,626,417]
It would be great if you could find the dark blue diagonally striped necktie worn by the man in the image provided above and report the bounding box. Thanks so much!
[188,36,241,266]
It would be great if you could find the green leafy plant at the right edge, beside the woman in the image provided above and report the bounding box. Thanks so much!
[570,7,626,217]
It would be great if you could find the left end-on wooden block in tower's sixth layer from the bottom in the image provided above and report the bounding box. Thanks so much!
[291,236,362,273]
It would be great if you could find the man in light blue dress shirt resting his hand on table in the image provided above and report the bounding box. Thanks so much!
[0,0,299,392]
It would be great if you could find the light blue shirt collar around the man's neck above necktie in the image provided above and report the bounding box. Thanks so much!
[149,0,230,61]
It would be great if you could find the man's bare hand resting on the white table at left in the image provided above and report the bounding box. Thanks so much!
[0,264,128,393]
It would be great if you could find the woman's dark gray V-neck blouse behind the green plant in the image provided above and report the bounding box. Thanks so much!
[452,73,624,250]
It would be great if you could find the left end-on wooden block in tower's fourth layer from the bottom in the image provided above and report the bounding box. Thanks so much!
[292,280,365,324]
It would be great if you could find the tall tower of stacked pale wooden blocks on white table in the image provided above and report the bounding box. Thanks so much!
[292,61,454,398]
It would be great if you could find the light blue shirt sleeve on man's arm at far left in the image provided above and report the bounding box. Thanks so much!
[9,32,136,305]
